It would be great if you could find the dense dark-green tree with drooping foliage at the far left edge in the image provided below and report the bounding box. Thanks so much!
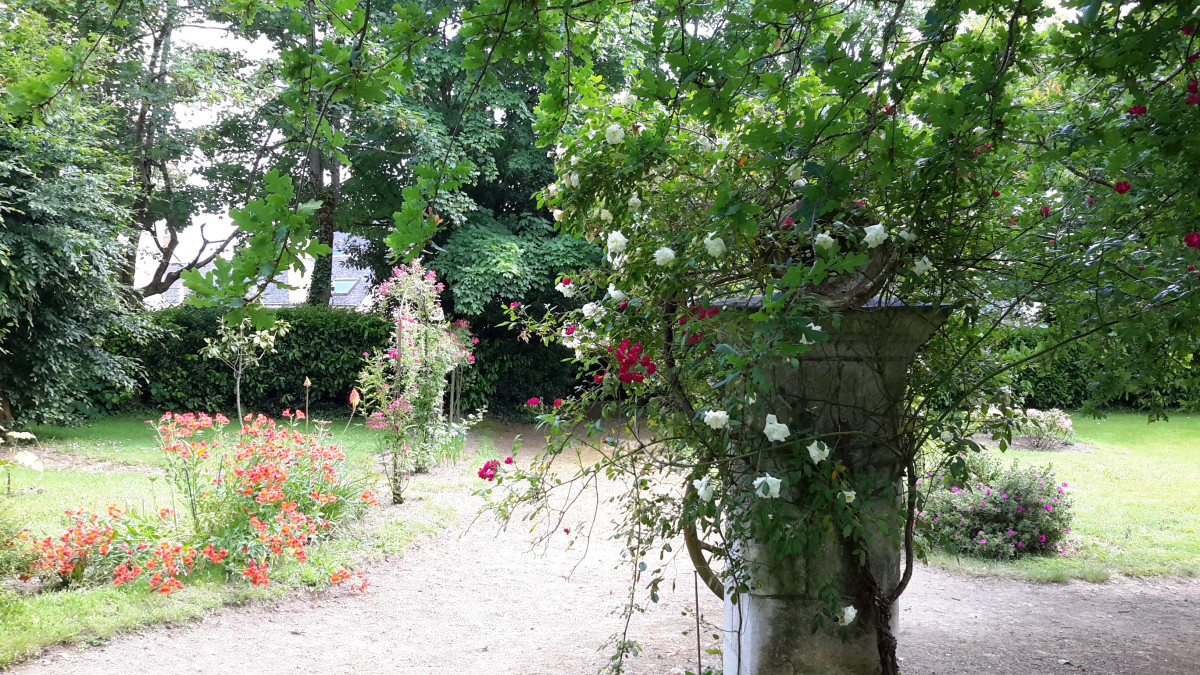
[0,10,143,422]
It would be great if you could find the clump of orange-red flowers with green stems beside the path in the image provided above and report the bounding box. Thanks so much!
[19,412,376,593]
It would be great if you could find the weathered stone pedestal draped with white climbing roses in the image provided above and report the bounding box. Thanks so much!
[724,305,947,675]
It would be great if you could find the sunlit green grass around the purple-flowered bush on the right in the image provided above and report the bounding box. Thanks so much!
[931,413,1200,581]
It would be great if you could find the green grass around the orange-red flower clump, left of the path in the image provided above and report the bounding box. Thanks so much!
[0,416,470,669]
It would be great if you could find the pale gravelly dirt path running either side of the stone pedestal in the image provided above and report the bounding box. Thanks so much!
[14,441,1200,675]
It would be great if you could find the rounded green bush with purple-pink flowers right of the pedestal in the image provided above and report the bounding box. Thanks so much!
[917,452,1072,560]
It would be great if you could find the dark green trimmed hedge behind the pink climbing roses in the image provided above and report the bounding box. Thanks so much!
[76,306,575,418]
